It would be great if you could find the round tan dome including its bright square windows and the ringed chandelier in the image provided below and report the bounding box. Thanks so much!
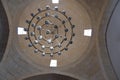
[16,0,92,68]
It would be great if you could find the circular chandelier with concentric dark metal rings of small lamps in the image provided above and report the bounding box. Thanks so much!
[24,5,75,57]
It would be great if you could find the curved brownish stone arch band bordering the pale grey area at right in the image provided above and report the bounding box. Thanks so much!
[98,0,119,80]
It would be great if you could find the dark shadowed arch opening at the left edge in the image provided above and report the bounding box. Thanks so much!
[0,0,9,62]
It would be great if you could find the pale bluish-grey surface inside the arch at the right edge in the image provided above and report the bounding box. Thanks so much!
[106,1,120,79]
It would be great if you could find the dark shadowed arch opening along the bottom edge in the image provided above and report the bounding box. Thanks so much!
[23,73,78,80]
